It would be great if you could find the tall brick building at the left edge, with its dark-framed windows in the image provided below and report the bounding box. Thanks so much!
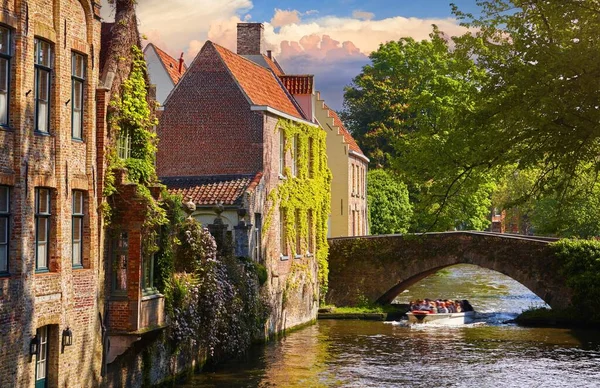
[0,0,103,387]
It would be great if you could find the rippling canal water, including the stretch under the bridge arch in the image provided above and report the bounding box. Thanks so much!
[185,265,600,388]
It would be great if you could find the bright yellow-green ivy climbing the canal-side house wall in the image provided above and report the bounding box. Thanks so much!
[265,119,331,300]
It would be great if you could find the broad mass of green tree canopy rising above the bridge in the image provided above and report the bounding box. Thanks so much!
[342,0,600,235]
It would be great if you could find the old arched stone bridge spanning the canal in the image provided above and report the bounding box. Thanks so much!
[326,231,572,308]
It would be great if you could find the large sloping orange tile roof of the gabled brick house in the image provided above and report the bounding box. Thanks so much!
[212,42,305,119]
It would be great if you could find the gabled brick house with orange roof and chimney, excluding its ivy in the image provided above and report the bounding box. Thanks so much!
[157,23,329,333]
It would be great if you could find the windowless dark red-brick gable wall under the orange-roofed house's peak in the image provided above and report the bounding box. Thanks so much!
[157,45,263,177]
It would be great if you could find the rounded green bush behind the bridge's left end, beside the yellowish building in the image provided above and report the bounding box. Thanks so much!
[367,169,412,234]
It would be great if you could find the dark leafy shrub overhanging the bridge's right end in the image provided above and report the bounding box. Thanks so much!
[551,240,600,321]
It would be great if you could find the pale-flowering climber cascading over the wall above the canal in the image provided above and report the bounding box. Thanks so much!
[169,217,269,361]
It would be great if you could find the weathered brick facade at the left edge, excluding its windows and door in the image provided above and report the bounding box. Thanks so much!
[0,0,103,387]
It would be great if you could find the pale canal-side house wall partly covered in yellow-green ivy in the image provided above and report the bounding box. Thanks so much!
[264,117,331,332]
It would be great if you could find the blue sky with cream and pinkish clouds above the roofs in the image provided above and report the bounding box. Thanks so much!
[102,0,477,110]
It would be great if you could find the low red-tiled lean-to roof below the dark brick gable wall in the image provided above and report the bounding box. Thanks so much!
[162,172,262,205]
